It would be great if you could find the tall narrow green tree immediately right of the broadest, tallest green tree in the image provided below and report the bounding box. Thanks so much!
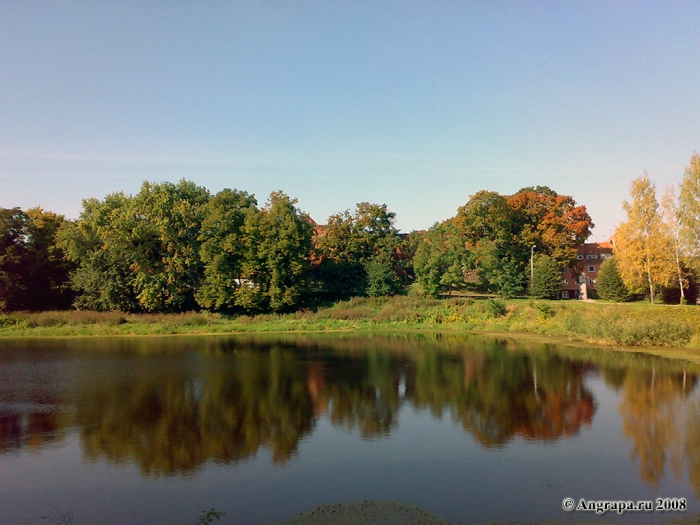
[195,188,257,309]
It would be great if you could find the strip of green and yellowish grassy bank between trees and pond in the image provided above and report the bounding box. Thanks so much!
[0,297,700,348]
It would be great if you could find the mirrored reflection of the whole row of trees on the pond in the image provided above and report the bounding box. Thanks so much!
[0,335,700,494]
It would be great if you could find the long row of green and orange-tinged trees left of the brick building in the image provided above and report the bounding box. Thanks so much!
[0,180,593,313]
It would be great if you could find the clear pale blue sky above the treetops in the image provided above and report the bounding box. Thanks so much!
[0,0,700,241]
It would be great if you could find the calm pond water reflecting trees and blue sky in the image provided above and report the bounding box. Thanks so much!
[0,334,700,525]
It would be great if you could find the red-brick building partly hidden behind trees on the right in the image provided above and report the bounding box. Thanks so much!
[561,242,613,299]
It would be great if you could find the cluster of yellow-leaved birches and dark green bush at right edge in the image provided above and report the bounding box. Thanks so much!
[597,154,700,304]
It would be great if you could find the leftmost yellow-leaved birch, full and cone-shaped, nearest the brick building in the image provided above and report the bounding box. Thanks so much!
[615,172,673,304]
